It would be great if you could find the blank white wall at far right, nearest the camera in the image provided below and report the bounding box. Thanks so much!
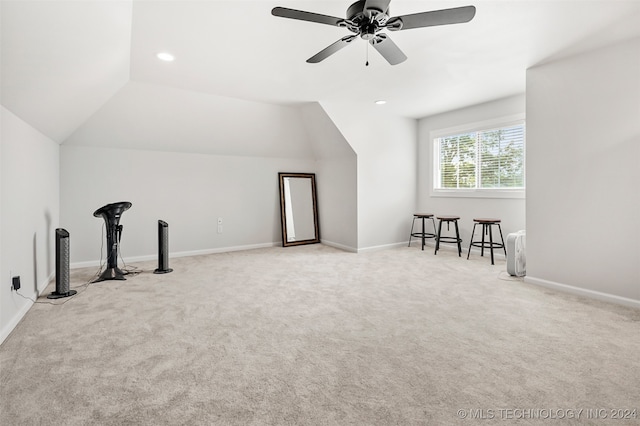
[527,38,640,306]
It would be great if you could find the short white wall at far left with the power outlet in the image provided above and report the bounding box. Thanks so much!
[0,107,60,342]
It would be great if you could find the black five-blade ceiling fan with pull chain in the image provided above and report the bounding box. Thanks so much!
[271,0,476,65]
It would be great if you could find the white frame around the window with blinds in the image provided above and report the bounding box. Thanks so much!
[429,114,527,198]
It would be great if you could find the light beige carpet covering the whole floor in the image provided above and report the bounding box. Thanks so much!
[0,244,640,425]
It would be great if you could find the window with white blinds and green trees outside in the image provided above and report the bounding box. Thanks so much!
[433,116,525,196]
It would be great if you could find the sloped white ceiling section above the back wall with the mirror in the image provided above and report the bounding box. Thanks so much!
[64,81,313,158]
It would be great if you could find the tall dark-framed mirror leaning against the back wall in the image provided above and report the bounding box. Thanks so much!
[278,173,320,247]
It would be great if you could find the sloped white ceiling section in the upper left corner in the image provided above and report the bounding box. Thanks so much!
[0,0,132,143]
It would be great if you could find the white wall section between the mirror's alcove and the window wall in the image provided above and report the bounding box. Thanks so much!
[322,102,417,251]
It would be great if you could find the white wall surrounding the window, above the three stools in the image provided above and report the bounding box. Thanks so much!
[418,95,529,248]
